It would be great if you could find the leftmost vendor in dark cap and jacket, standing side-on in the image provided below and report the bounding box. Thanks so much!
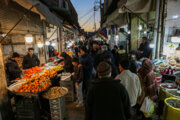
[6,52,22,85]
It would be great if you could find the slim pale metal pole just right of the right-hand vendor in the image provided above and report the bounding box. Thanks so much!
[152,0,160,59]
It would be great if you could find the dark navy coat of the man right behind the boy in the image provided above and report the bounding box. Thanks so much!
[80,53,94,80]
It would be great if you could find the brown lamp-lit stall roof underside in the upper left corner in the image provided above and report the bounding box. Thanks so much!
[0,2,43,34]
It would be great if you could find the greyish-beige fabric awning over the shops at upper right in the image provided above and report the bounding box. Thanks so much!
[103,0,156,27]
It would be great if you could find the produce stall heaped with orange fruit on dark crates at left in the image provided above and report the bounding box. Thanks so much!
[8,62,74,120]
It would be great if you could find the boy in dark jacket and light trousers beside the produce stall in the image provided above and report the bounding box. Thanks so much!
[72,58,83,107]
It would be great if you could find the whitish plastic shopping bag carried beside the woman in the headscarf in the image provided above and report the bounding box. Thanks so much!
[140,97,154,114]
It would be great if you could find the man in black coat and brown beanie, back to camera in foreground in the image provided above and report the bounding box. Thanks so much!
[85,62,131,120]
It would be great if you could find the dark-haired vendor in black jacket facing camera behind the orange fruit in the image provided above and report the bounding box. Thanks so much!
[23,48,40,69]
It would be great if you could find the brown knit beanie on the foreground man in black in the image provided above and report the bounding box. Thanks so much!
[97,62,112,77]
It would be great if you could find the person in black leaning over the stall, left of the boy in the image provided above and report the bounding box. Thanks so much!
[60,52,74,73]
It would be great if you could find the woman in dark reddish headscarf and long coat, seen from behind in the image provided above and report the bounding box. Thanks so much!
[138,59,157,105]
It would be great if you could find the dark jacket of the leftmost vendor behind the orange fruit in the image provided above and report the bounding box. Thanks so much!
[6,59,22,81]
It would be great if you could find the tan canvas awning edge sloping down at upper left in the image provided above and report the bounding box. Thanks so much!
[14,0,62,26]
